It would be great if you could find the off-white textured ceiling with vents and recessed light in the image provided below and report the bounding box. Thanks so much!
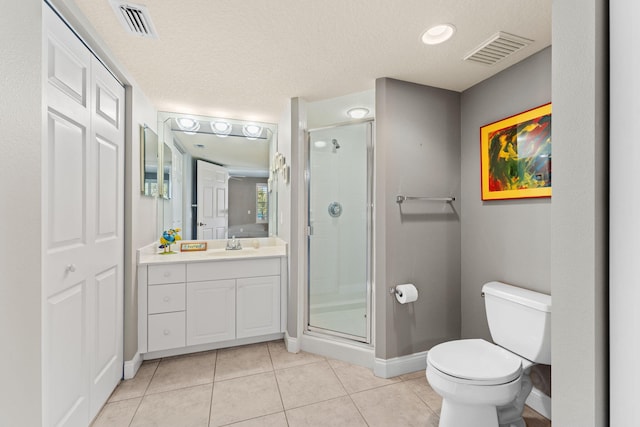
[70,0,551,122]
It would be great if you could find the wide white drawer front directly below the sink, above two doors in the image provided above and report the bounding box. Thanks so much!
[187,258,280,282]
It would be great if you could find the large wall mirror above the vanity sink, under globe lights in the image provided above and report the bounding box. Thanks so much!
[158,112,277,240]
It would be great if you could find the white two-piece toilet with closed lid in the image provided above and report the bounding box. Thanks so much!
[427,282,551,427]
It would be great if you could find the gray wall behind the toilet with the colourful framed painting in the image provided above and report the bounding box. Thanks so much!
[461,48,557,340]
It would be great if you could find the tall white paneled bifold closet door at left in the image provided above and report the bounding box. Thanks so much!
[42,7,124,426]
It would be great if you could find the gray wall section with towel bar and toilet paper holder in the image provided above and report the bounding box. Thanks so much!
[374,78,460,359]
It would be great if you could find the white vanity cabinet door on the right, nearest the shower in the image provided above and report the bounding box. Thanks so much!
[236,276,280,338]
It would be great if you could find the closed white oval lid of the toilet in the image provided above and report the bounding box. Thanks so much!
[427,339,522,385]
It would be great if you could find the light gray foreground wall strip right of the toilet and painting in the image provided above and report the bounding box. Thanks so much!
[550,0,608,427]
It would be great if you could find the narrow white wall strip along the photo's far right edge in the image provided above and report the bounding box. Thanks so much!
[609,0,640,426]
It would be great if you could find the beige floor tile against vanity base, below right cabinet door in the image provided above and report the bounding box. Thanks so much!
[215,343,273,381]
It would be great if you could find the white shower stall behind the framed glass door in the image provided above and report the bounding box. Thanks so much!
[305,121,373,343]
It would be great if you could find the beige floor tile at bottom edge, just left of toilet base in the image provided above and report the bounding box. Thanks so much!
[351,382,439,427]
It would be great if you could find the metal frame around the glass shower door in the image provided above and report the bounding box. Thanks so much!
[303,118,375,346]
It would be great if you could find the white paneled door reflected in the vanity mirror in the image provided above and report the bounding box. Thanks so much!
[196,160,229,240]
